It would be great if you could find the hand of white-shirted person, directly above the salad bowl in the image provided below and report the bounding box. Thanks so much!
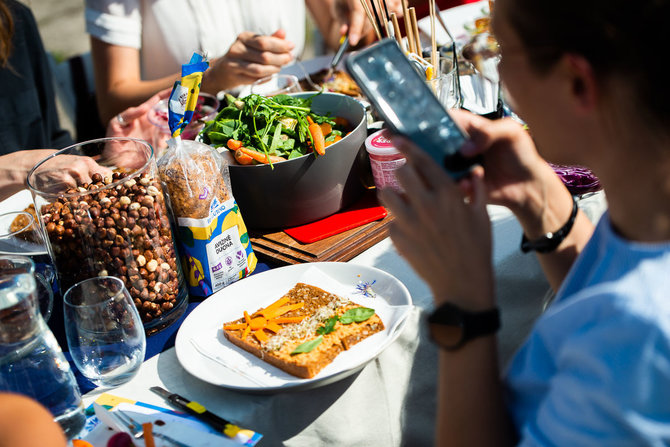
[203,29,295,93]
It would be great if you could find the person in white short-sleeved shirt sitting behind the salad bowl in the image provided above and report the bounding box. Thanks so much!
[86,0,402,122]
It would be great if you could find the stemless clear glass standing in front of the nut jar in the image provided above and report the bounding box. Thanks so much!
[63,276,146,388]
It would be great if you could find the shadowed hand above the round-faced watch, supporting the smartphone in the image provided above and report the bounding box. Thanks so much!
[381,137,495,310]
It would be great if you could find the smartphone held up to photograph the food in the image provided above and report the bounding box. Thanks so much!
[346,39,480,179]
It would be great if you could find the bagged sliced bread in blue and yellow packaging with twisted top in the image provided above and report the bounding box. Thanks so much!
[158,53,257,297]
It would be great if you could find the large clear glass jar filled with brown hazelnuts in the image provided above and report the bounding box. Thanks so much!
[28,138,188,334]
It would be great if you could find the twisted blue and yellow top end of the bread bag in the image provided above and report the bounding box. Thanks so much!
[168,53,209,138]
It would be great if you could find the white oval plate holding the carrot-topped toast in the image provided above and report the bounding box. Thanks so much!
[175,262,412,393]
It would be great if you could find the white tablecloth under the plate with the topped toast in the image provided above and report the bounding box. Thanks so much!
[84,194,605,447]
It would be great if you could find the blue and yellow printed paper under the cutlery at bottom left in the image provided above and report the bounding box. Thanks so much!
[75,393,262,447]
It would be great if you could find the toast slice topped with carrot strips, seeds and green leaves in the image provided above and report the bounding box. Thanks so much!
[223,283,384,379]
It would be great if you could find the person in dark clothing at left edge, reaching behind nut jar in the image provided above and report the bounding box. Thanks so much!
[0,0,113,200]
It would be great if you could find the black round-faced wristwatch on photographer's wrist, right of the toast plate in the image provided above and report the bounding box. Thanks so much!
[428,303,500,351]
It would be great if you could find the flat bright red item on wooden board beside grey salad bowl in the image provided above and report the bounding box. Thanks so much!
[284,193,388,244]
